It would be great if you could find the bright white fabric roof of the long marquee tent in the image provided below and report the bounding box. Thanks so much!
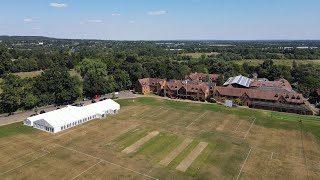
[27,99,120,127]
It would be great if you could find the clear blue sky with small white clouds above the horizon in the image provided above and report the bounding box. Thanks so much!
[0,0,320,40]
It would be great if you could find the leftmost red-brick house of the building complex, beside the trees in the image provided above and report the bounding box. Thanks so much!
[134,78,165,94]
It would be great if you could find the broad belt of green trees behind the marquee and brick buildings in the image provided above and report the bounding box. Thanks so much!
[0,41,320,112]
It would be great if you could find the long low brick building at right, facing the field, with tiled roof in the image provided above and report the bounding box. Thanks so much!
[213,86,313,115]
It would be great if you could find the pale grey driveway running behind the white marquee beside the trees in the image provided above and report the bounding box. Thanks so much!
[0,91,136,126]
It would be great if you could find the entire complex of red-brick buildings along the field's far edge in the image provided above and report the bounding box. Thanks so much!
[135,73,312,115]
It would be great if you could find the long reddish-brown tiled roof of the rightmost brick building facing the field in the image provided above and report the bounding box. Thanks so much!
[215,86,305,103]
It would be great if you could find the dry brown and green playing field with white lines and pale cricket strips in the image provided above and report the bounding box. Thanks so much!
[0,98,320,179]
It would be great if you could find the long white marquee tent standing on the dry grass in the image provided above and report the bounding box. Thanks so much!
[23,99,120,133]
